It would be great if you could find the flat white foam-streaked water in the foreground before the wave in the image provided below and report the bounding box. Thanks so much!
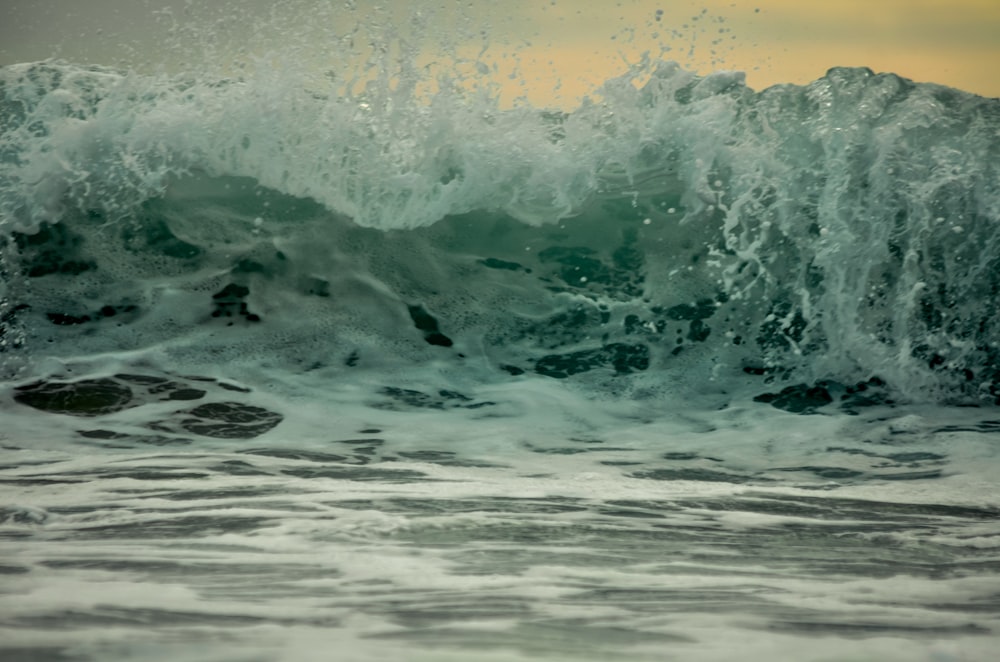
[0,368,1000,660]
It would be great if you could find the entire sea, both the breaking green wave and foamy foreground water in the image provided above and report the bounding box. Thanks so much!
[0,41,1000,662]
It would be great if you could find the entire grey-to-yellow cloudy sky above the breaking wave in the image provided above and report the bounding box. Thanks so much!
[0,0,1000,105]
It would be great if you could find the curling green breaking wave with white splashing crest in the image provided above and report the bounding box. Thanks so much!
[0,62,1000,407]
